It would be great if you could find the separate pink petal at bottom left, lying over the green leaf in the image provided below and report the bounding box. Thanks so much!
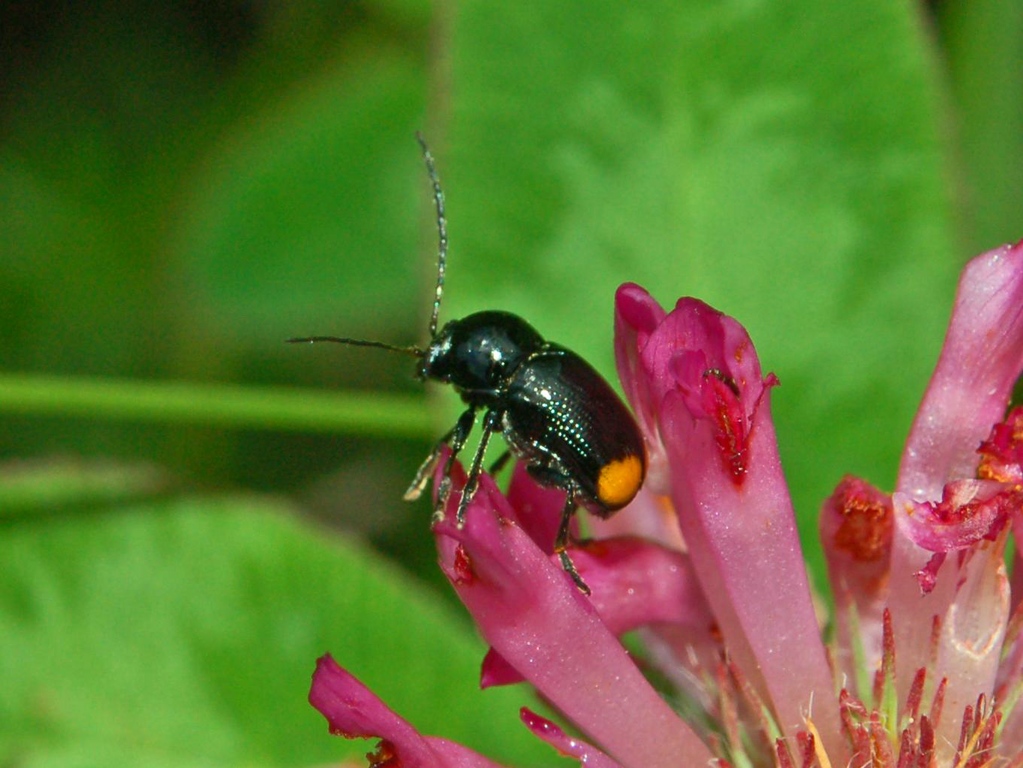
[309,656,507,768]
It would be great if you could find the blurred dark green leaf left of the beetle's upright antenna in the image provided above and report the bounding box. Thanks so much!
[177,51,428,344]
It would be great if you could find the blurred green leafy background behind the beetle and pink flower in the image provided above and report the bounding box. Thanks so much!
[0,0,1023,766]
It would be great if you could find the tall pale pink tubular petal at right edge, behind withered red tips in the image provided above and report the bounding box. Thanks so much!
[889,242,1023,728]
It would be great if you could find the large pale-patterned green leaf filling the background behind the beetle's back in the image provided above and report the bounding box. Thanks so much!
[440,0,961,572]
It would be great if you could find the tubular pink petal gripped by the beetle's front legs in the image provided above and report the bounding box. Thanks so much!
[435,477,711,768]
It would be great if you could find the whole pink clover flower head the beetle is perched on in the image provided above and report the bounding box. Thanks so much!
[310,243,1023,768]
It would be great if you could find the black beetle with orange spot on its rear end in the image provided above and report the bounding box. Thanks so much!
[287,133,647,594]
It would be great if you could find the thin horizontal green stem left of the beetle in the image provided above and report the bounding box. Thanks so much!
[0,373,433,438]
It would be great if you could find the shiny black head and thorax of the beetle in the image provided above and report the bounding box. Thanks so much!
[419,312,544,394]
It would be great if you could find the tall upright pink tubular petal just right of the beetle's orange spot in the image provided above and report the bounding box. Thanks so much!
[619,286,847,755]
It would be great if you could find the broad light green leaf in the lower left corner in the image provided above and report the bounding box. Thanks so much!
[0,469,550,767]
